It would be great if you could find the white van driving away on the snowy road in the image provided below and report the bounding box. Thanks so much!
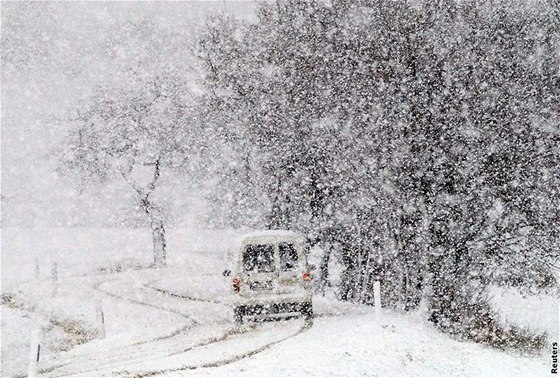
[224,230,315,323]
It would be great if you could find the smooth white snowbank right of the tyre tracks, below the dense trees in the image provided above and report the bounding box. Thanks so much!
[169,311,549,377]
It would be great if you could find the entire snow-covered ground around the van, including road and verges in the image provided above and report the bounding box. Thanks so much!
[2,229,558,377]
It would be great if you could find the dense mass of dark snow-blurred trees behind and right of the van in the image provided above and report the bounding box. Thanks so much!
[199,0,560,346]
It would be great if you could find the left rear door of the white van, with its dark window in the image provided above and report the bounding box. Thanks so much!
[241,243,278,296]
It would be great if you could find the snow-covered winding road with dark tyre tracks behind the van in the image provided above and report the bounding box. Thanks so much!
[32,272,305,376]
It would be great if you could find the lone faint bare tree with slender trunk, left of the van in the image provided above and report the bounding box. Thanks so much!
[60,71,196,267]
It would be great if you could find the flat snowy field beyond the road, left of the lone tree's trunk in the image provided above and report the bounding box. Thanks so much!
[2,228,152,291]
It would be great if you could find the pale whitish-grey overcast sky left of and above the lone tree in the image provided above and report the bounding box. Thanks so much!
[1,1,255,227]
